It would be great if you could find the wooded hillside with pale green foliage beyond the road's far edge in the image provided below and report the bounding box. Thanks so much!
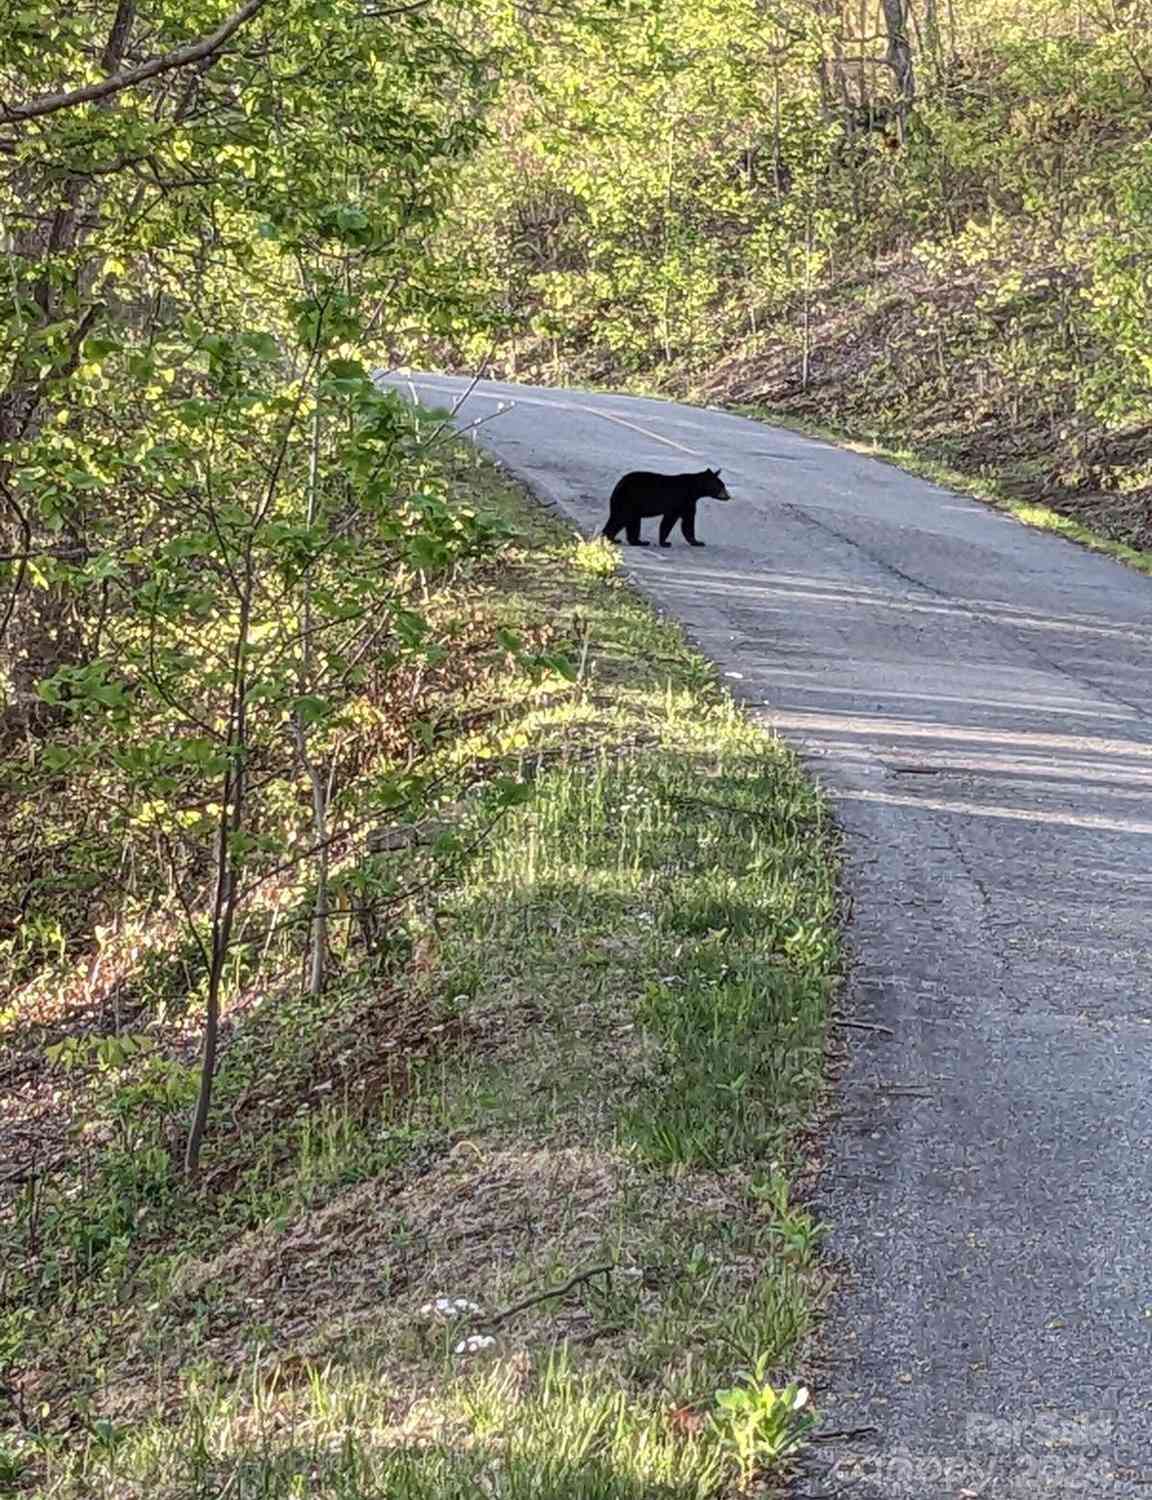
[420,0,1152,548]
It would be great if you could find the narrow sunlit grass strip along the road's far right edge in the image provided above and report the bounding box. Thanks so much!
[728,404,1152,575]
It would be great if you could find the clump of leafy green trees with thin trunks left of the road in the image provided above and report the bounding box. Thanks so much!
[0,0,491,1175]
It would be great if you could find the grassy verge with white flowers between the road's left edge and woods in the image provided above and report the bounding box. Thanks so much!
[0,458,837,1500]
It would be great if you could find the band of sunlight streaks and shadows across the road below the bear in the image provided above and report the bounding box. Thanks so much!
[639,558,1152,852]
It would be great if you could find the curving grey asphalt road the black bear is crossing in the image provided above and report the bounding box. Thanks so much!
[387,375,1152,1500]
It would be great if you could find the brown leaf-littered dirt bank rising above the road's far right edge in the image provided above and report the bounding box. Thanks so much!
[698,258,1152,549]
